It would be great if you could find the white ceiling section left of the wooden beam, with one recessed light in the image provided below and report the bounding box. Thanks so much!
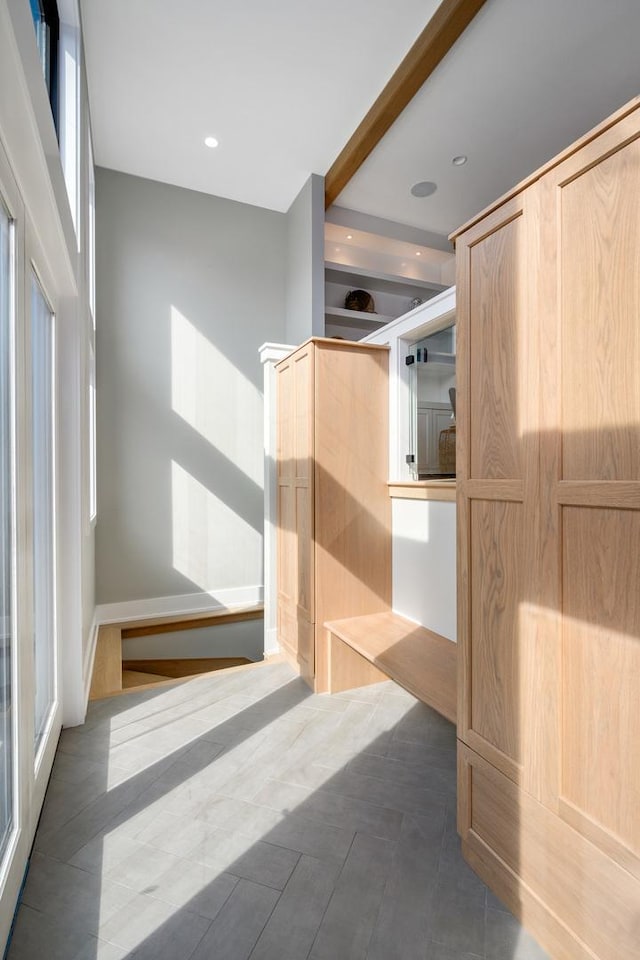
[80,0,439,211]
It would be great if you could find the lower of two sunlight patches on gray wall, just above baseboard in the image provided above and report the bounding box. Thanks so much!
[171,460,262,592]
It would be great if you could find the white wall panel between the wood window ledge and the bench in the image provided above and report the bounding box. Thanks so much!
[391,498,457,640]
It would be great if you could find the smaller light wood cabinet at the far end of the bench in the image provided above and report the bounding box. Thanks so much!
[275,339,391,692]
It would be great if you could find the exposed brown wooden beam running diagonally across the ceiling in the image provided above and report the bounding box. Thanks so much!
[325,0,486,209]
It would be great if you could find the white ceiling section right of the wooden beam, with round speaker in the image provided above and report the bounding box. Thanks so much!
[336,0,640,234]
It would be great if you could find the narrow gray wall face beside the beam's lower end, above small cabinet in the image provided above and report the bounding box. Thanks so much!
[284,173,324,344]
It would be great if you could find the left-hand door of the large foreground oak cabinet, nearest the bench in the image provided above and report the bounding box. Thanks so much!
[456,193,547,793]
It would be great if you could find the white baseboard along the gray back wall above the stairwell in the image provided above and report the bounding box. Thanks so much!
[95,585,264,624]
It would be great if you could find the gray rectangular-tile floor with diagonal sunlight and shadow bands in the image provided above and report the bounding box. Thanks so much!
[8,663,546,960]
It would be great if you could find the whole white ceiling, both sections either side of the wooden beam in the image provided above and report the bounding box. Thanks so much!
[81,0,640,234]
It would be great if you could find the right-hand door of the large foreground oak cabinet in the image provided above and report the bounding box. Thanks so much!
[538,110,640,880]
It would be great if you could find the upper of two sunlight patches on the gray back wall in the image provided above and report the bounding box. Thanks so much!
[171,306,263,486]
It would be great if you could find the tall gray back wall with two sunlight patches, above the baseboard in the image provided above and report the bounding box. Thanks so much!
[96,169,287,604]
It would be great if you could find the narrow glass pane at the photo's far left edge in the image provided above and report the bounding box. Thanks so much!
[0,199,14,856]
